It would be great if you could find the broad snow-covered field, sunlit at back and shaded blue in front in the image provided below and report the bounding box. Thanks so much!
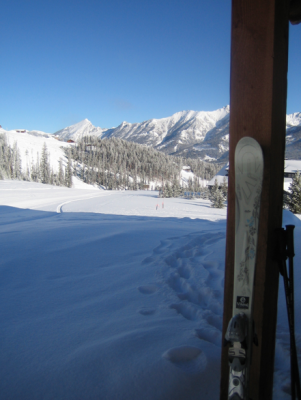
[0,181,301,400]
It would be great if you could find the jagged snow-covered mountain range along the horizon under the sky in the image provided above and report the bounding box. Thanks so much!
[55,106,301,162]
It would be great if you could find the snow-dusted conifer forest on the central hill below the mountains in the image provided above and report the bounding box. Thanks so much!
[70,136,220,190]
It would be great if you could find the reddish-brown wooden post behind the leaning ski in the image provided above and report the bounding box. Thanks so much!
[220,0,289,400]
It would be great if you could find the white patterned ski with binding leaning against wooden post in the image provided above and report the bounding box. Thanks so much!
[225,137,263,400]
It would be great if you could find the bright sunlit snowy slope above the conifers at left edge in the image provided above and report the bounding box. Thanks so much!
[0,129,70,172]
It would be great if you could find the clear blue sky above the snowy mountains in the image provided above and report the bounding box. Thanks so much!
[0,0,301,133]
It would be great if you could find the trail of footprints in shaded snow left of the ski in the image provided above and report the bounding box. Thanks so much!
[138,231,225,373]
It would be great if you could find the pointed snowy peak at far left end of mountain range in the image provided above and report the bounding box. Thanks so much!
[54,118,107,141]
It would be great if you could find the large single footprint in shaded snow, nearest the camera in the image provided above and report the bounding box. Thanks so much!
[162,346,207,374]
